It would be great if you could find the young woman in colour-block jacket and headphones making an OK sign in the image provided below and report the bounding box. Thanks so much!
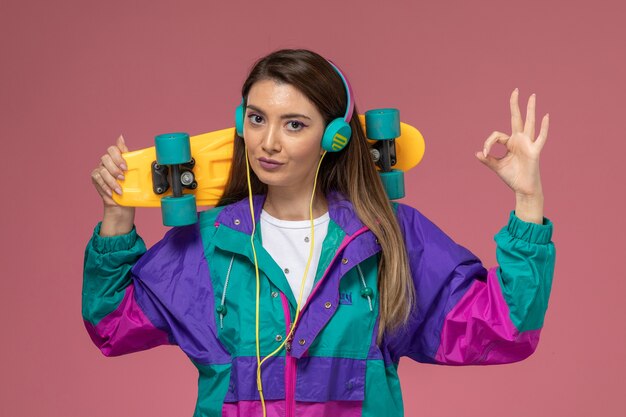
[83,50,555,417]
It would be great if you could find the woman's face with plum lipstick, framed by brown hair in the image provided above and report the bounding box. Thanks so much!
[244,80,326,191]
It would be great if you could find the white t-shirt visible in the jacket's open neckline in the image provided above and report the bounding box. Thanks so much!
[261,210,330,308]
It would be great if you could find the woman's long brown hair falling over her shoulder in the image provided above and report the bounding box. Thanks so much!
[217,49,415,343]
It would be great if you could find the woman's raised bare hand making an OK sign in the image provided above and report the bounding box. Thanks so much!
[476,88,549,198]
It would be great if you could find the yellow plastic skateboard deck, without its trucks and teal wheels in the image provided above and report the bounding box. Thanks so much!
[113,115,424,207]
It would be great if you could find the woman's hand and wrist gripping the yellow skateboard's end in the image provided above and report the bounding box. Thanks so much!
[91,135,135,236]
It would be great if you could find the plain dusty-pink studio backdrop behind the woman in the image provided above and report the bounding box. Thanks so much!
[0,0,626,417]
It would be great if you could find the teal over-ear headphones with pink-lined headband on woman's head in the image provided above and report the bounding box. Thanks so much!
[235,61,354,152]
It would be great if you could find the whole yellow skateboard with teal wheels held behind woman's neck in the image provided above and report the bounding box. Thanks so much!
[113,109,424,226]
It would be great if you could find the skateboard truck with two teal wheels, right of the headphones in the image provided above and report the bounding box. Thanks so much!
[365,109,404,200]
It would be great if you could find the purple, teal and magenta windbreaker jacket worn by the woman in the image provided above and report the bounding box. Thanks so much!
[83,195,555,417]
